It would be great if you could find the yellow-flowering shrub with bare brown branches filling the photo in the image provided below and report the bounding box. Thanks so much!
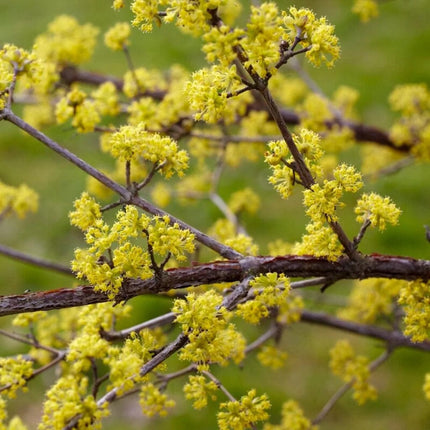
[0,0,430,430]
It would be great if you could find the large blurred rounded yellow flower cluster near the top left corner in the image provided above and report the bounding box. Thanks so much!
[35,15,99,66]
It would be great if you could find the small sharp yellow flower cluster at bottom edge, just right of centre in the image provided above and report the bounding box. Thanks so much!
[217,390,271,430]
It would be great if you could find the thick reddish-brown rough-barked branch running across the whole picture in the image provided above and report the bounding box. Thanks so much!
[0,254,430,316]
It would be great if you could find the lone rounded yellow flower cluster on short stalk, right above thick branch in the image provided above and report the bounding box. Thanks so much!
[355,193,401,230]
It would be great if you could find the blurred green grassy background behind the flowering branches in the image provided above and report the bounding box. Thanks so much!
[0,0,430,430]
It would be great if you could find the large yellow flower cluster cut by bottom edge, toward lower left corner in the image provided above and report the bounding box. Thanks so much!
[38,375,108,430]
